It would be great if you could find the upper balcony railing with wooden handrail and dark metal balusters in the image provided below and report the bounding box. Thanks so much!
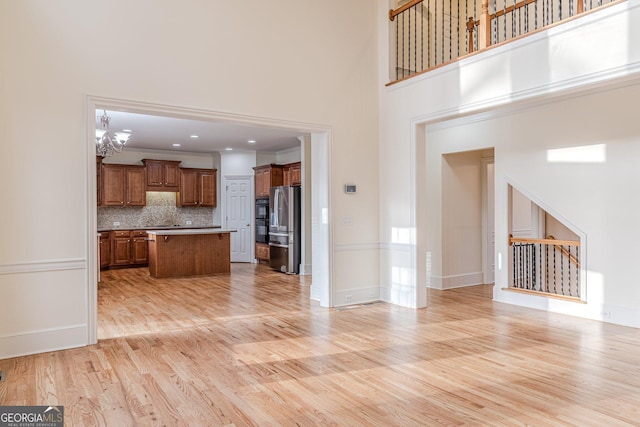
[389,0,623,83]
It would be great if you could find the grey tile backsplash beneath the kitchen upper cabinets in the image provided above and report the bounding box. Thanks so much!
[98,191,214,229]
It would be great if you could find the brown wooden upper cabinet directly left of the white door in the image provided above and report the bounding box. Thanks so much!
[176,168,218,208]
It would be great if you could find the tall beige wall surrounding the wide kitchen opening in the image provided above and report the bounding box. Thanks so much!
[0,0,378,358]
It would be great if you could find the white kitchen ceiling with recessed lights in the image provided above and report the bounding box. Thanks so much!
[96,110,302,153]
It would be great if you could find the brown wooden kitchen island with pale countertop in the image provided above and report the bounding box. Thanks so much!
[148,228,235,278]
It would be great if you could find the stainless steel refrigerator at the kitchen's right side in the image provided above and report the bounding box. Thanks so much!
[269,185,301,274]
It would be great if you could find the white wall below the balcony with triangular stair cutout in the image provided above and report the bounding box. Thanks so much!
[379,0,640,326]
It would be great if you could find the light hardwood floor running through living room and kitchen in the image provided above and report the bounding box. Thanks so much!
[0,264,640,426]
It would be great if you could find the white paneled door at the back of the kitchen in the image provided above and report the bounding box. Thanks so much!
[225,177,253,262]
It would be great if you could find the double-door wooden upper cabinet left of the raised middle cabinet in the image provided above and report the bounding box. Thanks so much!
[102,164,147,206]
